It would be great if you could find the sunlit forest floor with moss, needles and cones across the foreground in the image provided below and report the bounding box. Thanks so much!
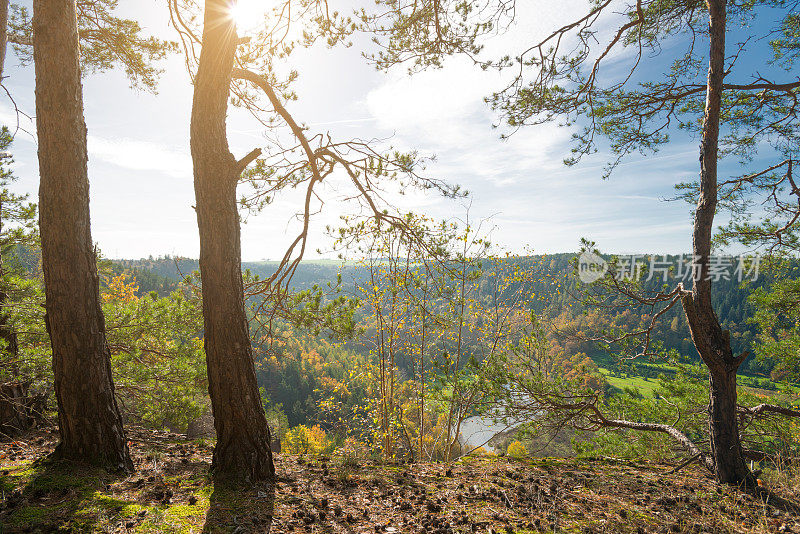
[0,430,800,534]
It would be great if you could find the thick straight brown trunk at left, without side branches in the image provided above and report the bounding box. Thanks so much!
[33,0,133,469]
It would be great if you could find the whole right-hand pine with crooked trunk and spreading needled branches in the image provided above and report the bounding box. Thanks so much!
[365,0,800,487]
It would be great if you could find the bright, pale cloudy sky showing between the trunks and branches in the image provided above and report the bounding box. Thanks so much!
[0,0,776,260]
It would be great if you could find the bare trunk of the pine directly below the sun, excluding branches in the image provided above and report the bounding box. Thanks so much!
[191,0,275,482]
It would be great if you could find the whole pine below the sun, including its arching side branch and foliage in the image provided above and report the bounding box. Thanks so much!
[170,0,454,482]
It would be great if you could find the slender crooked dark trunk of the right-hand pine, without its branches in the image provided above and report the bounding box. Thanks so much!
[683,0,755,486]
